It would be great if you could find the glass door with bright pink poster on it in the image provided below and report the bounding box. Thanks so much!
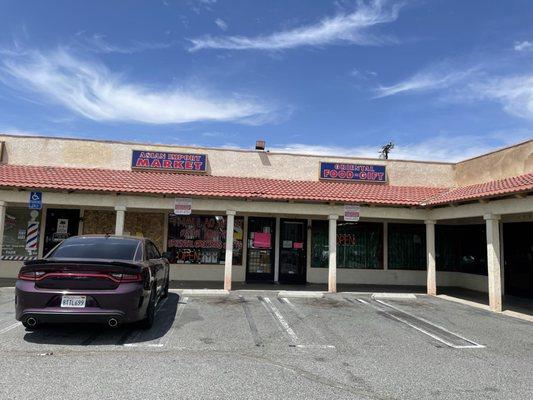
[246,217,276,282]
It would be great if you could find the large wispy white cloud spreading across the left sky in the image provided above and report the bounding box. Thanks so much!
[0,49,276,124]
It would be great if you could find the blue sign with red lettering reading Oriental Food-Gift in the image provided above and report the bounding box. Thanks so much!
[320,162,387,182]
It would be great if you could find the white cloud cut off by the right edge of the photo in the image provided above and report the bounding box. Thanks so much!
[468,75,533,119]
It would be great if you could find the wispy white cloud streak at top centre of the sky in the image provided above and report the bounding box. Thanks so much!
[190,0,400,51]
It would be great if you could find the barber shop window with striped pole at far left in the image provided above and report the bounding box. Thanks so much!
[2,207,41,260]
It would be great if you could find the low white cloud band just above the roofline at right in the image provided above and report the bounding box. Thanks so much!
[269,132,531,162]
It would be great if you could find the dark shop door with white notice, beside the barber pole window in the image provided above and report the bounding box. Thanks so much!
[43,208,80,255]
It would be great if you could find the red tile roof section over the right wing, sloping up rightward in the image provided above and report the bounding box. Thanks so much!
[425,173,533,205]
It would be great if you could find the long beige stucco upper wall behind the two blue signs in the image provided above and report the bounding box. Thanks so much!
[0,135,454,187]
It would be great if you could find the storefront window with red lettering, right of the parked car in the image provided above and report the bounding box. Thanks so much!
[167,214,244,265]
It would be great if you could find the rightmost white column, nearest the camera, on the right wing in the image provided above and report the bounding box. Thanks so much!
[483,214,502,312]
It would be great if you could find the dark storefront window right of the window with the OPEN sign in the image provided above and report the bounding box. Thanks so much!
[388,224,426,270]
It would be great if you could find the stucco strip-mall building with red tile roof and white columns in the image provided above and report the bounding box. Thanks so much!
[0,135,533,310]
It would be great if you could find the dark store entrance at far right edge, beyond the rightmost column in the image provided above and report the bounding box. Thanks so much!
[503,222,533,299]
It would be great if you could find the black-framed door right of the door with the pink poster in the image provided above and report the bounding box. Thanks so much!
[279,219,307,283]
